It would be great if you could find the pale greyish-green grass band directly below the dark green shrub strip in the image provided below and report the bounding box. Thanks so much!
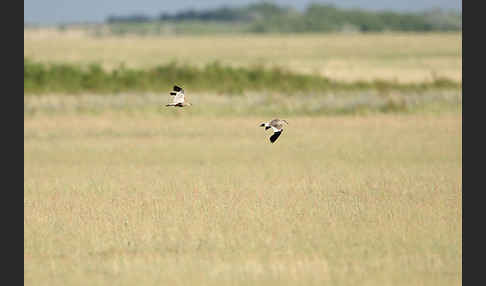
[24,90,462,117]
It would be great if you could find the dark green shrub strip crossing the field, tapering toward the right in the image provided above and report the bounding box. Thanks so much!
[24,58,462,94]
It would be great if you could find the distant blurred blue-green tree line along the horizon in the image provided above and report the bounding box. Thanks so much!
[106,2,462,33]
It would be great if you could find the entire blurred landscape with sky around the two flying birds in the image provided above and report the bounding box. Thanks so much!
[24,0,462,285]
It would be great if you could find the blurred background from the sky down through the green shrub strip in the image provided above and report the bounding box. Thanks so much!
[24,0,462,110]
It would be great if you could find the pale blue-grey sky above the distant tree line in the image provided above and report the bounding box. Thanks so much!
[24,0,462,25]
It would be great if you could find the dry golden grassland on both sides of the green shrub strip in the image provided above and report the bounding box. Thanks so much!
[24,29,462,286]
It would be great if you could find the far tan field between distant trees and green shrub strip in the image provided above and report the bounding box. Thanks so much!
[24,29,462,82]
